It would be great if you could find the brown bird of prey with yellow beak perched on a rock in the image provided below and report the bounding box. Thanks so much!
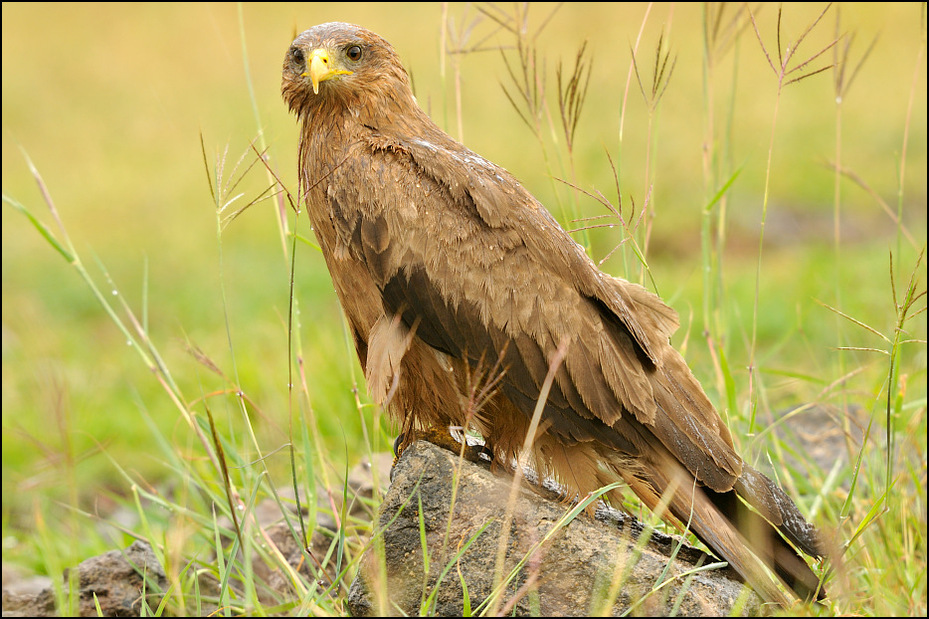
[281,22,823,604]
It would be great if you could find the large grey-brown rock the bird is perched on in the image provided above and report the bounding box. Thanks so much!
[348,442,761,616]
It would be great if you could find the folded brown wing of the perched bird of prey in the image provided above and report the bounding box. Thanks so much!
[329,130,741,490]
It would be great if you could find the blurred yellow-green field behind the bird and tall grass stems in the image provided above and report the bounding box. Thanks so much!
[2,3,926,580]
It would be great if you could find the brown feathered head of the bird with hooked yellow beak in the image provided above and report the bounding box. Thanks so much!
[281,22,412,118]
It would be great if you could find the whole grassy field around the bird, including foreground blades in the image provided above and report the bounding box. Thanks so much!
[2,3,927,615]
